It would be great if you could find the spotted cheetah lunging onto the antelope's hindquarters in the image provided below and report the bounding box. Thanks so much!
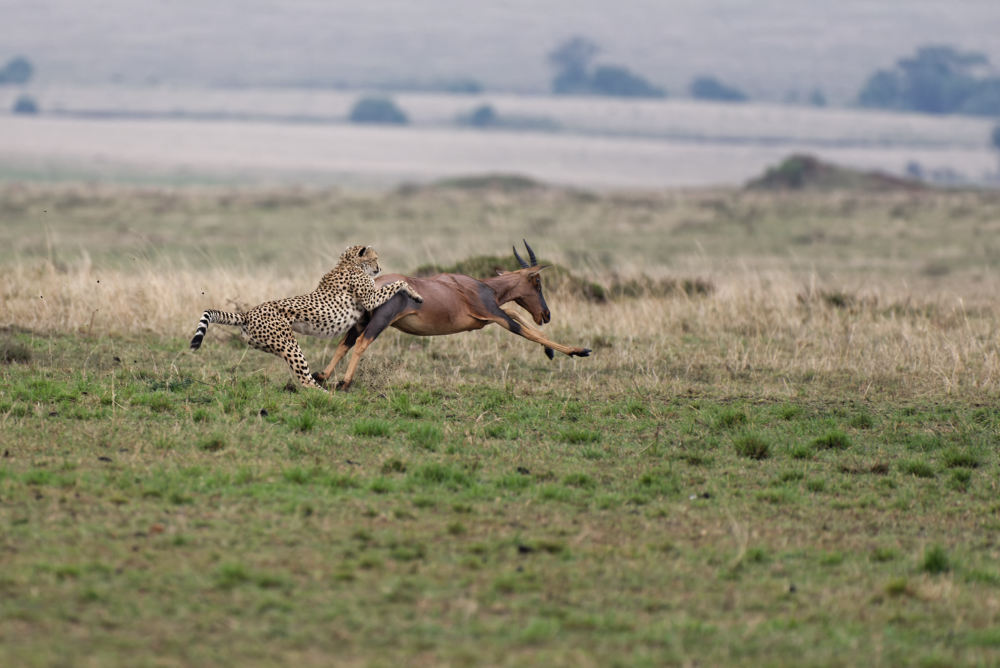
[191,246,423,392]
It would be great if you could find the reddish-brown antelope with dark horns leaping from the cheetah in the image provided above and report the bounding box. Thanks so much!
[313,239,591,390]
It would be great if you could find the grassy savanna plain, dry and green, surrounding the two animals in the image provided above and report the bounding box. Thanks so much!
[0,179,1000,666]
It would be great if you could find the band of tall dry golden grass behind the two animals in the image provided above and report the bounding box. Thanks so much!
[7,262,1000,397]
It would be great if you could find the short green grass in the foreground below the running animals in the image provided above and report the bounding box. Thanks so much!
[0,334,1000,665]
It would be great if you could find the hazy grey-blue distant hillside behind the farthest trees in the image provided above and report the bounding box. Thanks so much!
[0,0,1000,104]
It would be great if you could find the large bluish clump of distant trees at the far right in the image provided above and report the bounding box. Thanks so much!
[858,46,1000,115]
